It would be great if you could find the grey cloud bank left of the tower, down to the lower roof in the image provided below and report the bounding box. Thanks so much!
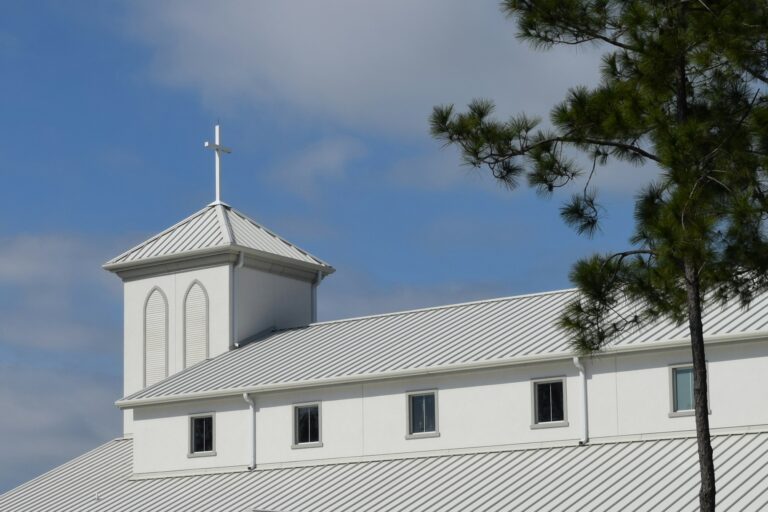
[0,234,124,492]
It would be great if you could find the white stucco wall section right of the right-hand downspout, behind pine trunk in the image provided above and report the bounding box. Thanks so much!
[589,342,768,439]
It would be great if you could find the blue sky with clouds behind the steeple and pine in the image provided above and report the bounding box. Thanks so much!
[0,0,653,491]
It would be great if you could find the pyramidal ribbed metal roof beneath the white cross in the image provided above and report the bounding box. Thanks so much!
[104,202,334,274]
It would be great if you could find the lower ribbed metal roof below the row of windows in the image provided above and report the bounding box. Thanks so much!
[0,432,768,512]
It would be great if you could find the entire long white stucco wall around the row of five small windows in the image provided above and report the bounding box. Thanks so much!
[126,342,768,472]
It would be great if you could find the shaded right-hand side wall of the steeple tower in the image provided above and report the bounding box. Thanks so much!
[235,267,312,341]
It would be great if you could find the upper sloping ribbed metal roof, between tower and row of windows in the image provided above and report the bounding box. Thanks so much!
[118,290,768,407]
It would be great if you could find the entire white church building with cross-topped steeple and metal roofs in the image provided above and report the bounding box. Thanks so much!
[0,130,768,512]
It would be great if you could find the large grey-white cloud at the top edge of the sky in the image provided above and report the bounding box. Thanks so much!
[129,0,598,137]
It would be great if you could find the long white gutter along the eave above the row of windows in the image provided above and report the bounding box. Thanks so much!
[115,332,768,409]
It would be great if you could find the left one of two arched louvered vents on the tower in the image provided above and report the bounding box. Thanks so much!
[144,288,168,386]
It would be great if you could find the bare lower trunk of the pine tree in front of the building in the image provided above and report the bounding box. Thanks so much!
[685,262,715,512]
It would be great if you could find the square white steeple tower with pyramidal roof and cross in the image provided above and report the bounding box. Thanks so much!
[104,124,334,408]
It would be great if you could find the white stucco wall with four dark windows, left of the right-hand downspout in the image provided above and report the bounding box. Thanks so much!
[127,363,579,473]
